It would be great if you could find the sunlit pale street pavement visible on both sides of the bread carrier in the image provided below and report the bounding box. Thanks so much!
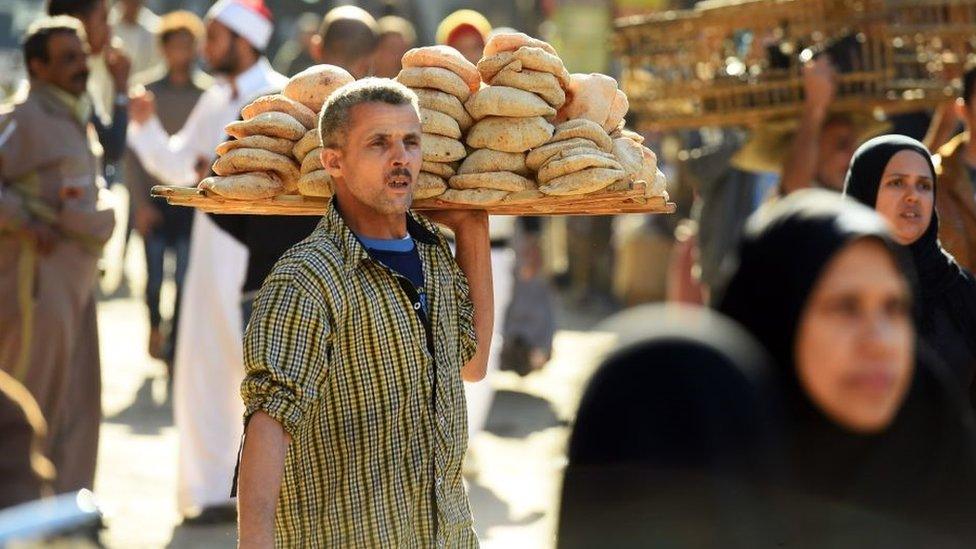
[95,219,611,549]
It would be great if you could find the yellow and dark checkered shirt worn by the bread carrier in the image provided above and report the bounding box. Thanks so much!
[241,203,478,547]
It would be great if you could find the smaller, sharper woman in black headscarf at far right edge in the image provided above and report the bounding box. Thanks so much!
[844,135,976,400]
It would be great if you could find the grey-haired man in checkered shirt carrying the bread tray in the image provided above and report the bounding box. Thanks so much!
[239,78,493,548]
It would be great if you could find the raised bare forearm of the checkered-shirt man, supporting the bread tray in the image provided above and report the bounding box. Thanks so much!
[454,215,495,381]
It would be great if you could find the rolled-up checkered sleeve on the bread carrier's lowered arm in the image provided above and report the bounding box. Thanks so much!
[241,275,331,439]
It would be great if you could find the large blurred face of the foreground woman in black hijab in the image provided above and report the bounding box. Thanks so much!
[794,239,915,433]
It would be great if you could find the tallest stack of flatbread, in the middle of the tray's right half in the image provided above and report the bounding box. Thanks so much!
[440,33,569,205]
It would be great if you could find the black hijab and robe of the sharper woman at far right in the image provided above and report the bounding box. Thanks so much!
[844,135,976,387]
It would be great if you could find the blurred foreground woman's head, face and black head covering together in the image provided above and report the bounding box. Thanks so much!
[717,190,915,434]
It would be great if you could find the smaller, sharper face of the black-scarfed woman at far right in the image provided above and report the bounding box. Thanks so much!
[874,150,935,246]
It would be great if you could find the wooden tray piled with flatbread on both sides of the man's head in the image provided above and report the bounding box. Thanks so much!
[153,33,675,215]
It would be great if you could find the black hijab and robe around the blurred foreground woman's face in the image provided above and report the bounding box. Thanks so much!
[717,190,976,540]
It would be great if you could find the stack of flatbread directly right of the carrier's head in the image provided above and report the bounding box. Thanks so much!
[396,46,481,200]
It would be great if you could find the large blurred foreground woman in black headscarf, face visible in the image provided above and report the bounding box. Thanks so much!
[717,191,976,539]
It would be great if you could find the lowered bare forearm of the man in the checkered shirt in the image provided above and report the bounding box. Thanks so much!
[237,412,289,549]
